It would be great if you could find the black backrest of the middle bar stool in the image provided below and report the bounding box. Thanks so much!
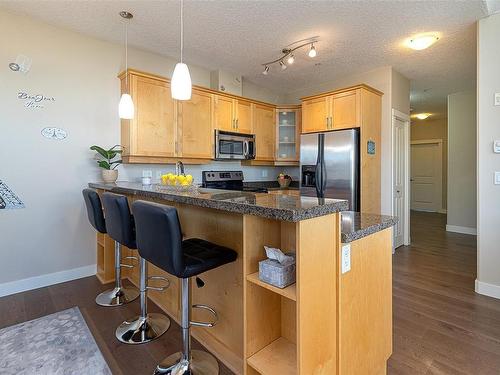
[102,192,137,249]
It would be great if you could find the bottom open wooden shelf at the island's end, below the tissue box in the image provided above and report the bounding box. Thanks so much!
[247,337,297,375]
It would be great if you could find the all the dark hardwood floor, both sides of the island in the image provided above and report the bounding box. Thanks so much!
[0,212,500,375]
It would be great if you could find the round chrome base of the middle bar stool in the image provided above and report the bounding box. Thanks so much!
[115,313,170,345]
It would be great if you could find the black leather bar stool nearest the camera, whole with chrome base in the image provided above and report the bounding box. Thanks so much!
[132,201,237,375]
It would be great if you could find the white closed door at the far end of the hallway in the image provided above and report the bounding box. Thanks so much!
[411,140,442,212]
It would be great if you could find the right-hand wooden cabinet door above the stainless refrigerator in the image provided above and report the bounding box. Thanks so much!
[330,89,361,130]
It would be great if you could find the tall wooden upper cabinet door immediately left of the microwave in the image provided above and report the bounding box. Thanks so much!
[177,89,214,159]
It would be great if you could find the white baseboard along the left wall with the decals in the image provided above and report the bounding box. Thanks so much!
[0,264,97,297]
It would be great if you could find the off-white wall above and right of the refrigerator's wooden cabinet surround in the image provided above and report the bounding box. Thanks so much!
[285,66,410,215]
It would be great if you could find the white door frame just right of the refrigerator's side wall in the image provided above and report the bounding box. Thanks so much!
[391,108,411,252]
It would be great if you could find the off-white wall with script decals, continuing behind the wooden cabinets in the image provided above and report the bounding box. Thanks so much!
[0,11,286,295]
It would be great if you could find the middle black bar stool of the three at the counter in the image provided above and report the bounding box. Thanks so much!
[102,192,170,344]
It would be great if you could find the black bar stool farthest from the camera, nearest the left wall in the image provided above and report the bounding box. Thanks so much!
[82,189,139,306]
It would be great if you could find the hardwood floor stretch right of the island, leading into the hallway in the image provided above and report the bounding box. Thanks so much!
[388,211,500,375]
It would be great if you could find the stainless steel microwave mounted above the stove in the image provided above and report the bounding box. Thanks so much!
[215,130,255,160]
